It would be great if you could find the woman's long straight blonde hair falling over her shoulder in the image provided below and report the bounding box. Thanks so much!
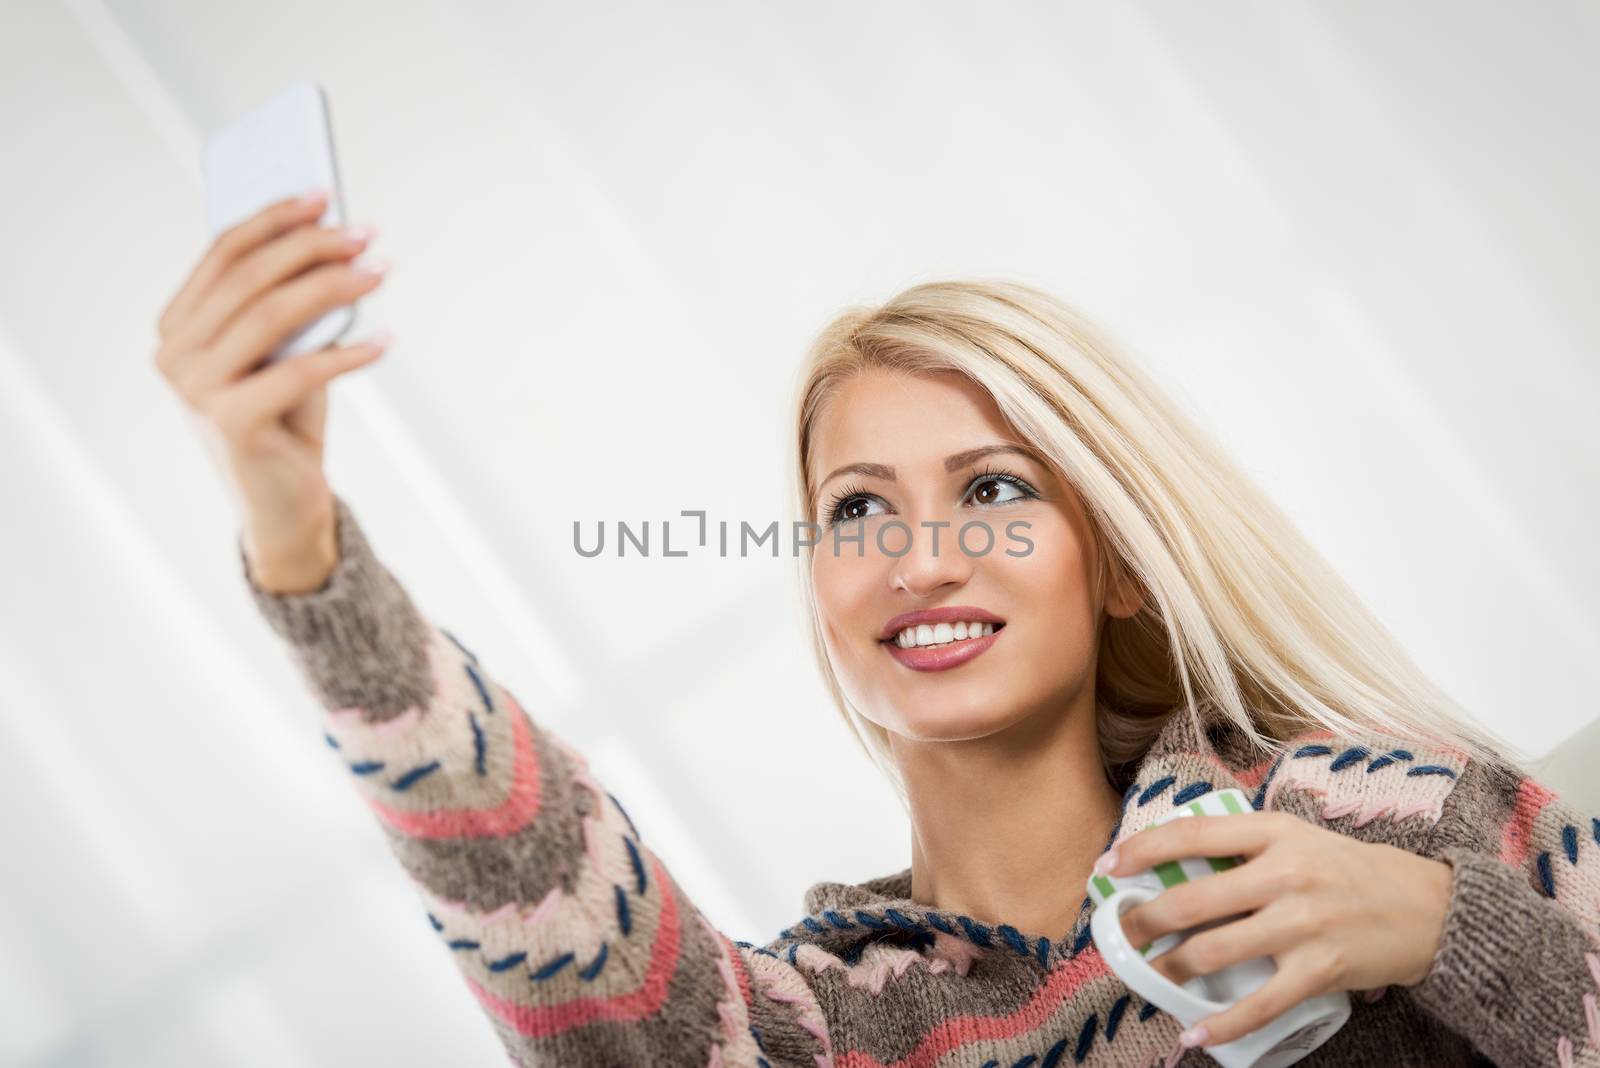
[790,281,1509,801]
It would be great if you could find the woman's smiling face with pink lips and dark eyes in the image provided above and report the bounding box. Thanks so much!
[811,368,1136,740]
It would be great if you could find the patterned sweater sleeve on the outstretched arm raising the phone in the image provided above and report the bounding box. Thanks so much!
[238,496,832,1068]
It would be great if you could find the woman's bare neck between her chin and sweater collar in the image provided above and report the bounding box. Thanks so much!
[891,692,1122,937]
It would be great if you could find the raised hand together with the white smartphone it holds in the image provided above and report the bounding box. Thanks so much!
[155,83,389,593]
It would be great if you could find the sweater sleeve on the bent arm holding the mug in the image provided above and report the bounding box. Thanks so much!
[1410,761,1600,1068]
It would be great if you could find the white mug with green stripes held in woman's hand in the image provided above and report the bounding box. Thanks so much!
[1088,790,1350,1068]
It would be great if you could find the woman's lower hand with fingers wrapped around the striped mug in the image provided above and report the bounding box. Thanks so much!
[1101,812,1453,1046]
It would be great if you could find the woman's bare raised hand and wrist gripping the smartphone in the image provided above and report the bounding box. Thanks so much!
[155,193,387,593]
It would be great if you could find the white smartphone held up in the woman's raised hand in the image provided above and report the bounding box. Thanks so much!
[200,82,355,363]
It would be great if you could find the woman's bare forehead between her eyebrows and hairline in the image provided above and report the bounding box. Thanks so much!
[811,368,1014,463]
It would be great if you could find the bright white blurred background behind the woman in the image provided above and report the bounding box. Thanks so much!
[0,0,1600,1068]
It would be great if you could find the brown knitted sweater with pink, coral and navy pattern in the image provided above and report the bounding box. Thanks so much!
[238,497,1600,1068]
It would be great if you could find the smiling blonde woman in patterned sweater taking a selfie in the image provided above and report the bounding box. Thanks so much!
[157,187,1600,1068]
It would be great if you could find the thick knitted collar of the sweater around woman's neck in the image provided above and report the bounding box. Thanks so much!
[780,710,1259,972]
